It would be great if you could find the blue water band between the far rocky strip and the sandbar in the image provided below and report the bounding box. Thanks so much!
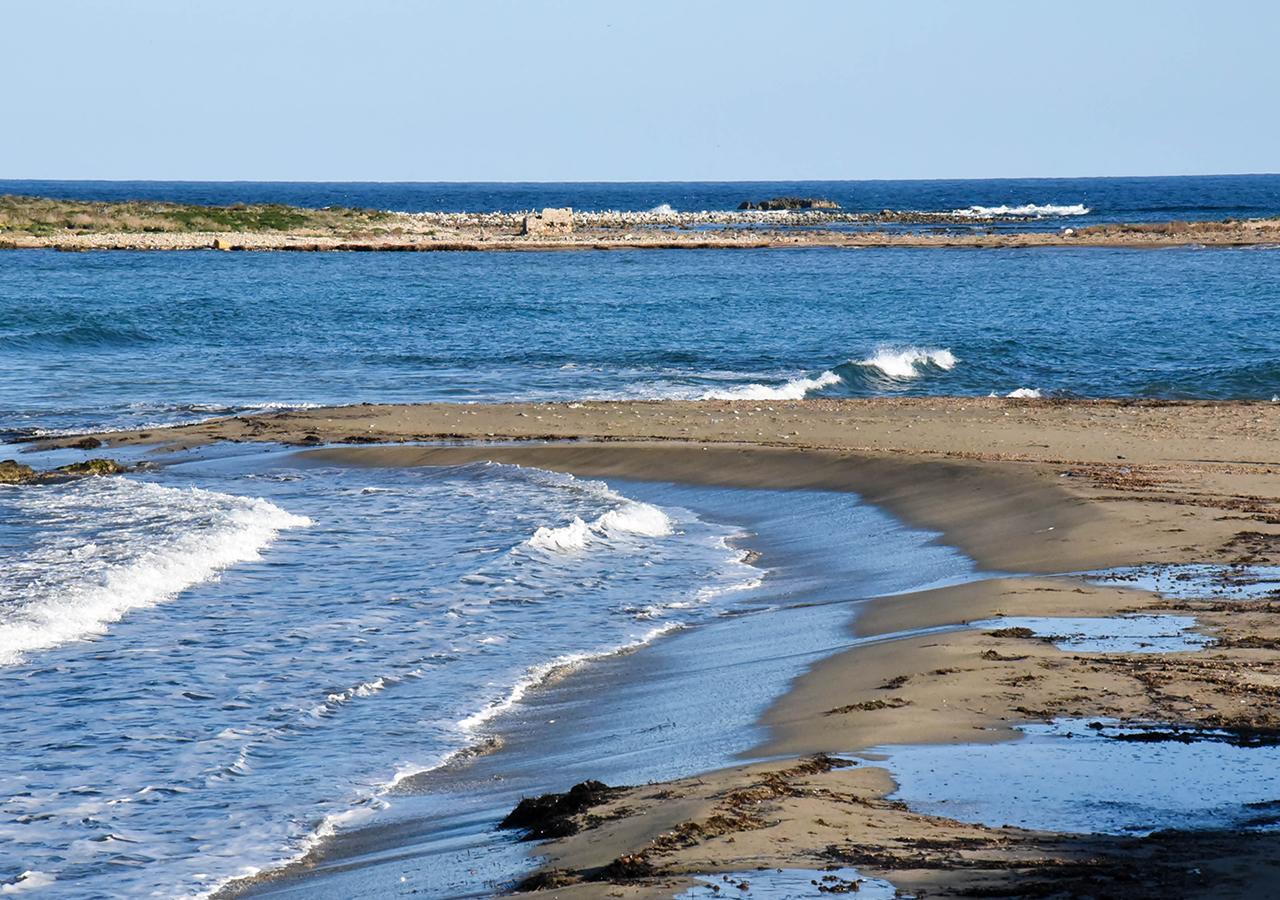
[0,240,1280,433]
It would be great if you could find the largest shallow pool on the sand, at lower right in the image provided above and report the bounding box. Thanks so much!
[878,719,1280,835]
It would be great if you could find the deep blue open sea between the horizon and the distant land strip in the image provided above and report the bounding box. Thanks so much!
[0,175,1280,227]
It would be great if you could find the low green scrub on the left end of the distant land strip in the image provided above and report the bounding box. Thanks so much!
[0,195,392,236]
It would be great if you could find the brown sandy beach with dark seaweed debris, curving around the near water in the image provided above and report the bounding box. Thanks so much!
[30,398,1280,896]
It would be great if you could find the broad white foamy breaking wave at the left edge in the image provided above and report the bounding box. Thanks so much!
[0,478,311,666]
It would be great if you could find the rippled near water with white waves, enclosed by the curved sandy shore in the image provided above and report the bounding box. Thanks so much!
[0,449,972,895]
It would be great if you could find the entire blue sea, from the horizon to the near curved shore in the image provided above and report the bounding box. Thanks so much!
[0,175,1280,897]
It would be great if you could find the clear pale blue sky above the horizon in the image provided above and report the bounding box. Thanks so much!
[0,0,1280,181]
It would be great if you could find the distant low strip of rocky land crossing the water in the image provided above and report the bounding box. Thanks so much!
[0,196,1280,252]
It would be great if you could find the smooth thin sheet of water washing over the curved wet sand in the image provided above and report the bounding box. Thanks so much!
[227,471,978,897]
